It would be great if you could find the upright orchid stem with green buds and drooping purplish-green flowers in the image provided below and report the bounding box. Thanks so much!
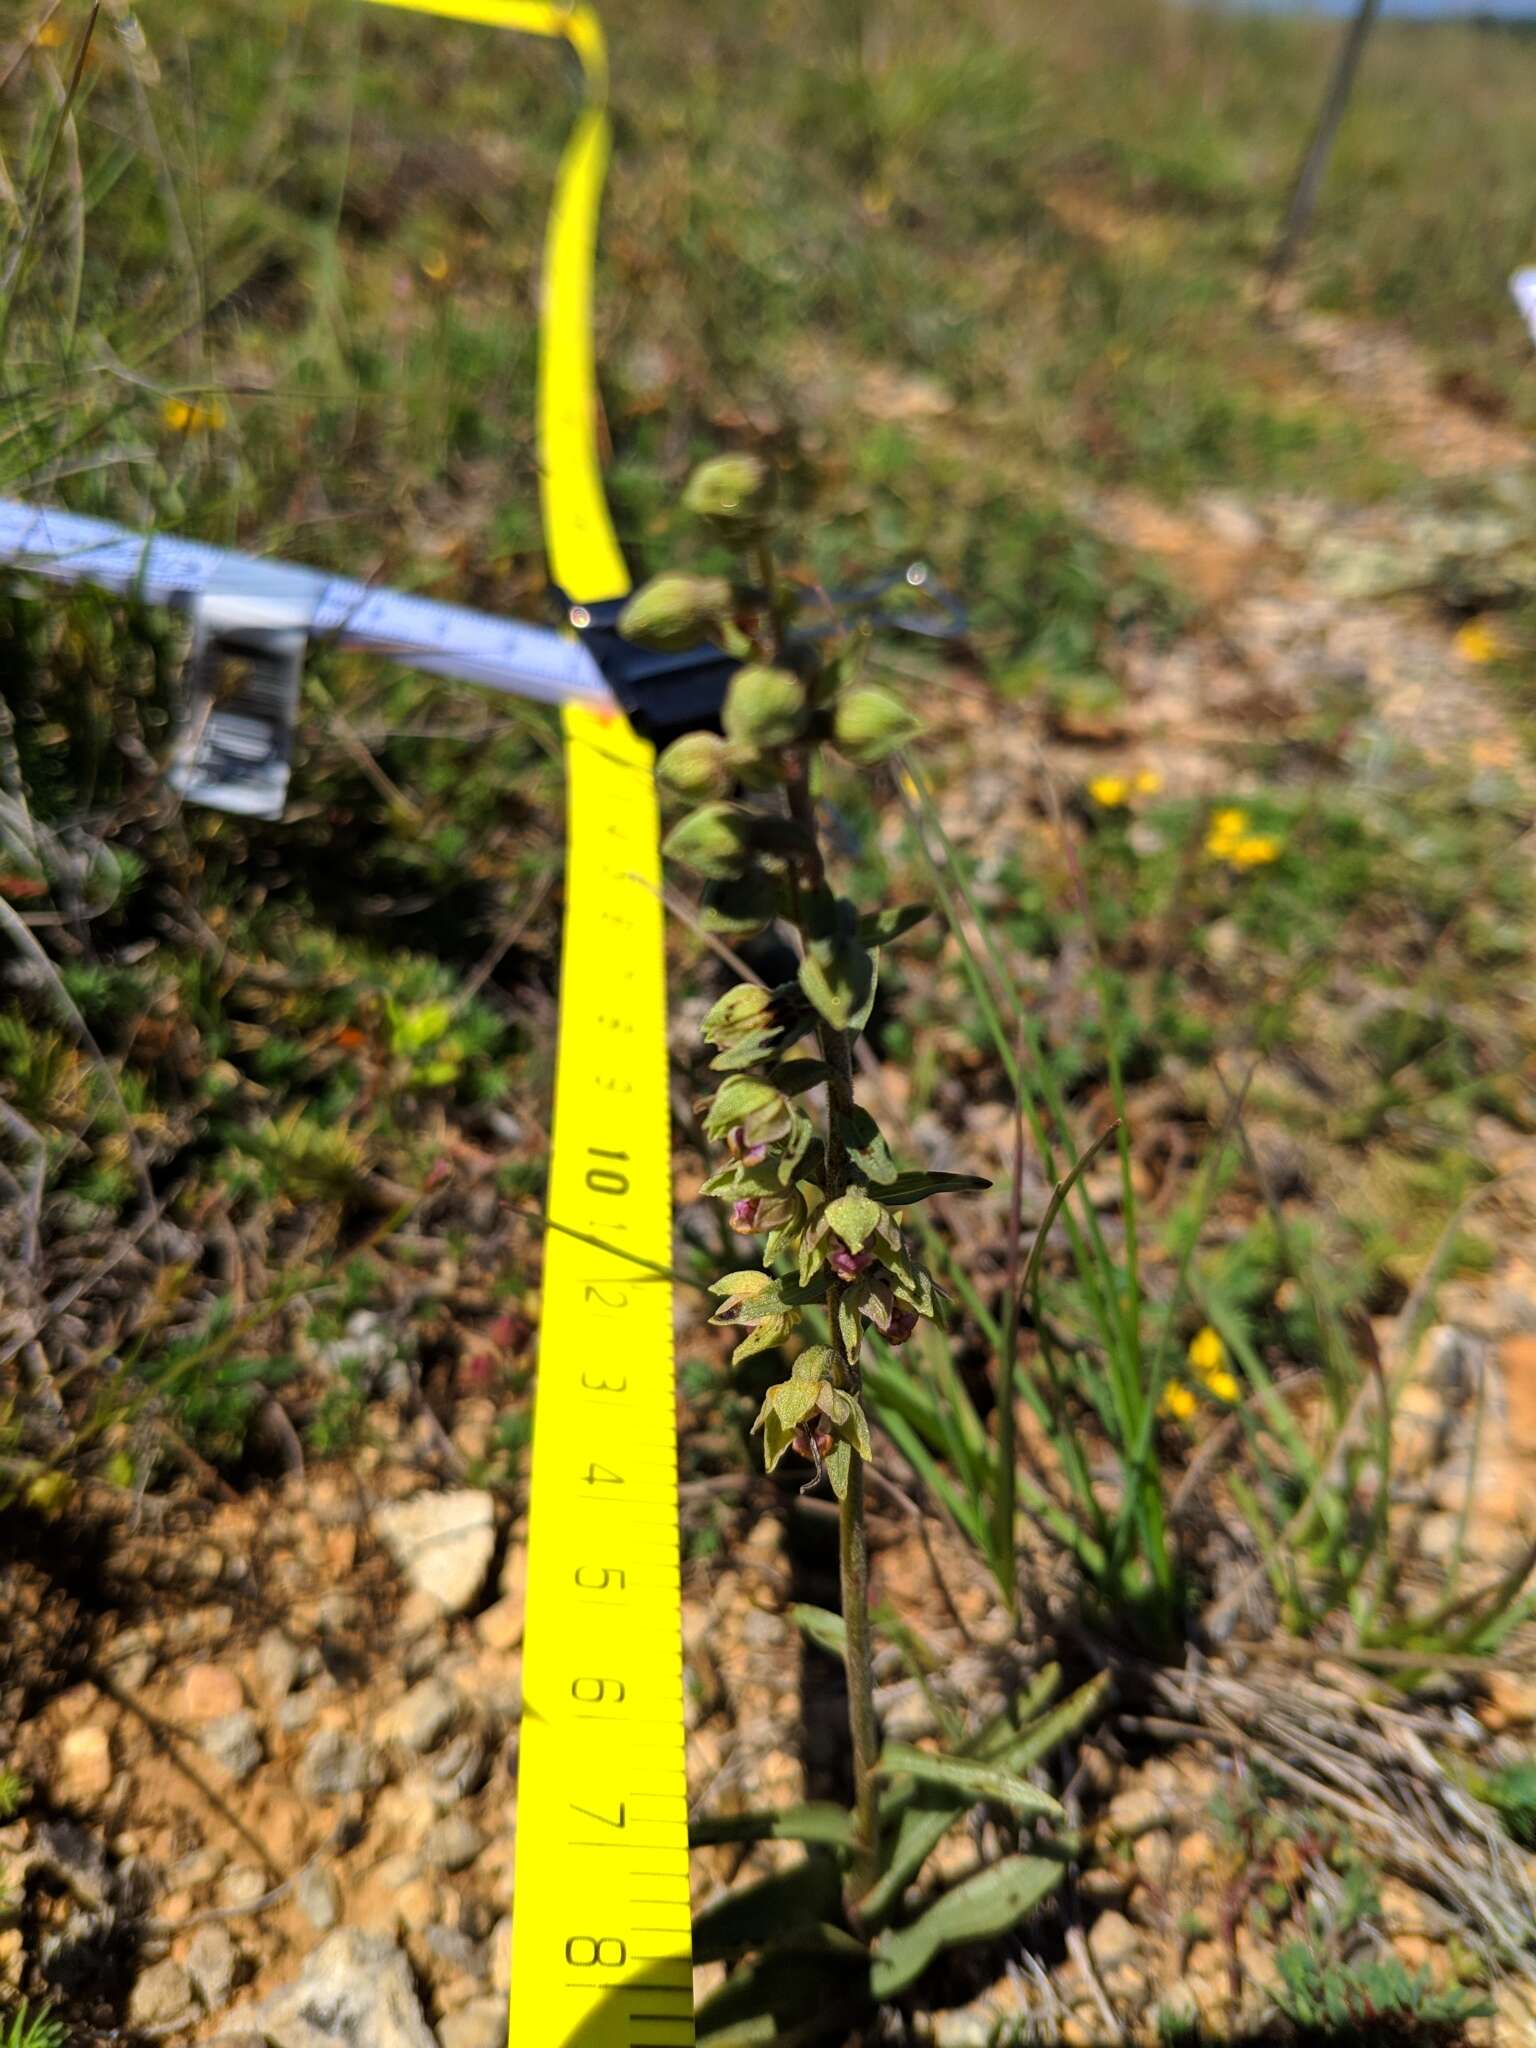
[621,455,987,1888]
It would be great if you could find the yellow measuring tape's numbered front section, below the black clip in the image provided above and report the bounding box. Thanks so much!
[510,707,694,2048]
